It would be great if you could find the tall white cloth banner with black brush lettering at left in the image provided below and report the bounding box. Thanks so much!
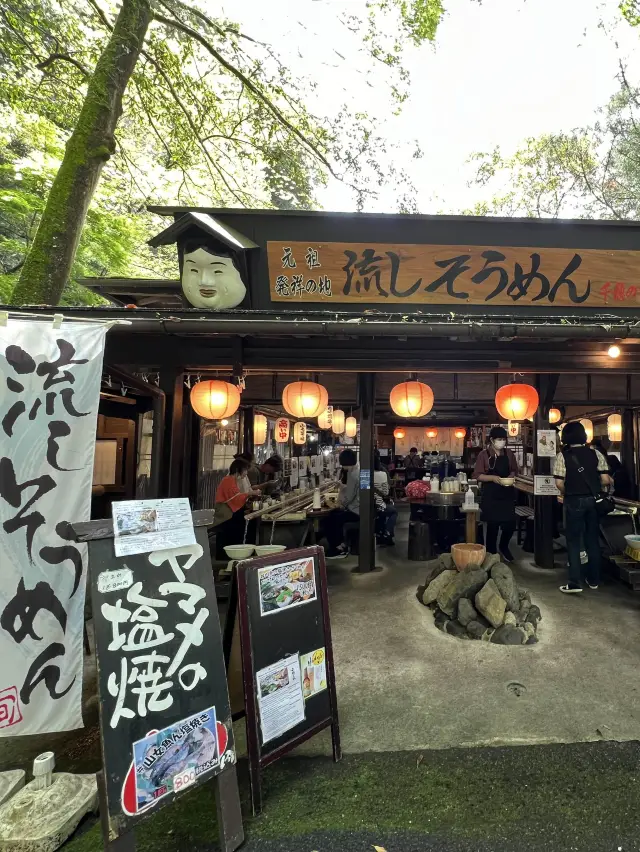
[0,319,106,736]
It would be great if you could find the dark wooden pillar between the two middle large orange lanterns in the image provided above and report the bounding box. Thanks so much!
[358,373,376,573]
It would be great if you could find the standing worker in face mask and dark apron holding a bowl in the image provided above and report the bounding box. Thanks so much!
[473,426,518,562]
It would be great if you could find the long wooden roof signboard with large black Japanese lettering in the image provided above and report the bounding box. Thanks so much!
[267,241,640,308]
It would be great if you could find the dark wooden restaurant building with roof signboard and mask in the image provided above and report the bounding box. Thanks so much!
[28,207,640,572]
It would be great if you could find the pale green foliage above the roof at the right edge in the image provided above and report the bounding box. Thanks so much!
[472,79,640,219]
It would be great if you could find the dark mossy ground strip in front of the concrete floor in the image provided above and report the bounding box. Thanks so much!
[61,743,640,852]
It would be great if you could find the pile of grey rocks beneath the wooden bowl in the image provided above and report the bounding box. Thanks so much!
[416,553,542,645]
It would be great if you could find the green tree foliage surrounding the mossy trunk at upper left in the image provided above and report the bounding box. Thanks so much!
[0,0,443,299]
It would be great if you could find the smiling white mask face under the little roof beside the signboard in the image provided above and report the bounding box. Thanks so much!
[182,248,247,311]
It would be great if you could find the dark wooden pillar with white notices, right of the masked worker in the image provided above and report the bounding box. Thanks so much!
[533,374,558,568]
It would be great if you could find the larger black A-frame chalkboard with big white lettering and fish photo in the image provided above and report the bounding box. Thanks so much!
[73,511,244,852]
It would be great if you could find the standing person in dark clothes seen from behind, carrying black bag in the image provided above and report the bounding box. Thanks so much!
[553,421,611,594]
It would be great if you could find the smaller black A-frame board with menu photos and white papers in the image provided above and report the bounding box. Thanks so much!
[237,547,342,813]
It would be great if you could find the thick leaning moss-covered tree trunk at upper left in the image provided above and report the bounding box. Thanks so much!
[13,0,152,305]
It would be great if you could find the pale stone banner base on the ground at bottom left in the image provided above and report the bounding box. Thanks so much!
[0,772,98,852]
